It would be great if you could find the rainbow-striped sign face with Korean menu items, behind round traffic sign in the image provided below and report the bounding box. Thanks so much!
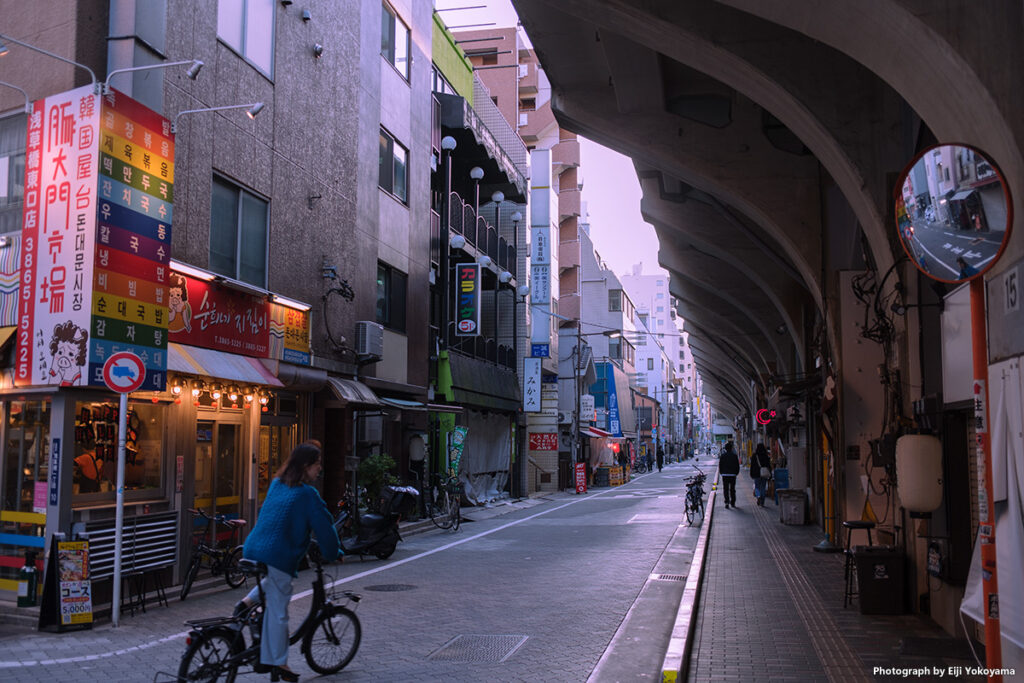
[88,90,174,391]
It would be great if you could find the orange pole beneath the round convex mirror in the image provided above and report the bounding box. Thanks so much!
[971,275,1002,683]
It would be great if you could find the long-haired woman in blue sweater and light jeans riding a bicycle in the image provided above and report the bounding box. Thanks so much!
[234,442,339,681]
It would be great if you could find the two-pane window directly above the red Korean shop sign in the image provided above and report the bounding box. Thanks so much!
[210,175,270,288]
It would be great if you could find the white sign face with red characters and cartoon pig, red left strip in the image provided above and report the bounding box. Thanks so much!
[14,86,100,386]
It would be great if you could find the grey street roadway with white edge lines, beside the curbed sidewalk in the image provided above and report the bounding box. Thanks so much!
[0,463,710,682]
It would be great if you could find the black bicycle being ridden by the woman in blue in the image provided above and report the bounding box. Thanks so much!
[178,545,362,683]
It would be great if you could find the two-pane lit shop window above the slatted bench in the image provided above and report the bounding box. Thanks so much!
[73,400,166,504]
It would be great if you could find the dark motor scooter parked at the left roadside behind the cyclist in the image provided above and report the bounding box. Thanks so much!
[334,486,420,560]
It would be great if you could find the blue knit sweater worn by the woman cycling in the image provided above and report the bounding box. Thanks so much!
[242,477,338,577]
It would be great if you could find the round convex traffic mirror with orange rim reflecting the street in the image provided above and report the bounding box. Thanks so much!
[896,144,1013,284]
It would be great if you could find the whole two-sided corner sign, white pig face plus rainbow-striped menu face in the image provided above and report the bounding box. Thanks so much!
[15,86,174,390]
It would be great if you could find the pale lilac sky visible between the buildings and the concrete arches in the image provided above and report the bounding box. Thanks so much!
[434,0,666,282]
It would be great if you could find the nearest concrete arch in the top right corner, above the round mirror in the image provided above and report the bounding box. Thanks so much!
[717,0,1024,272]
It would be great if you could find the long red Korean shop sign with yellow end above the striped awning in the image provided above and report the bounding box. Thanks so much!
[168,272,310,366]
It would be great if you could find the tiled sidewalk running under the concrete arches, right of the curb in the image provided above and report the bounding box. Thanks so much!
[665,476,985,683]
